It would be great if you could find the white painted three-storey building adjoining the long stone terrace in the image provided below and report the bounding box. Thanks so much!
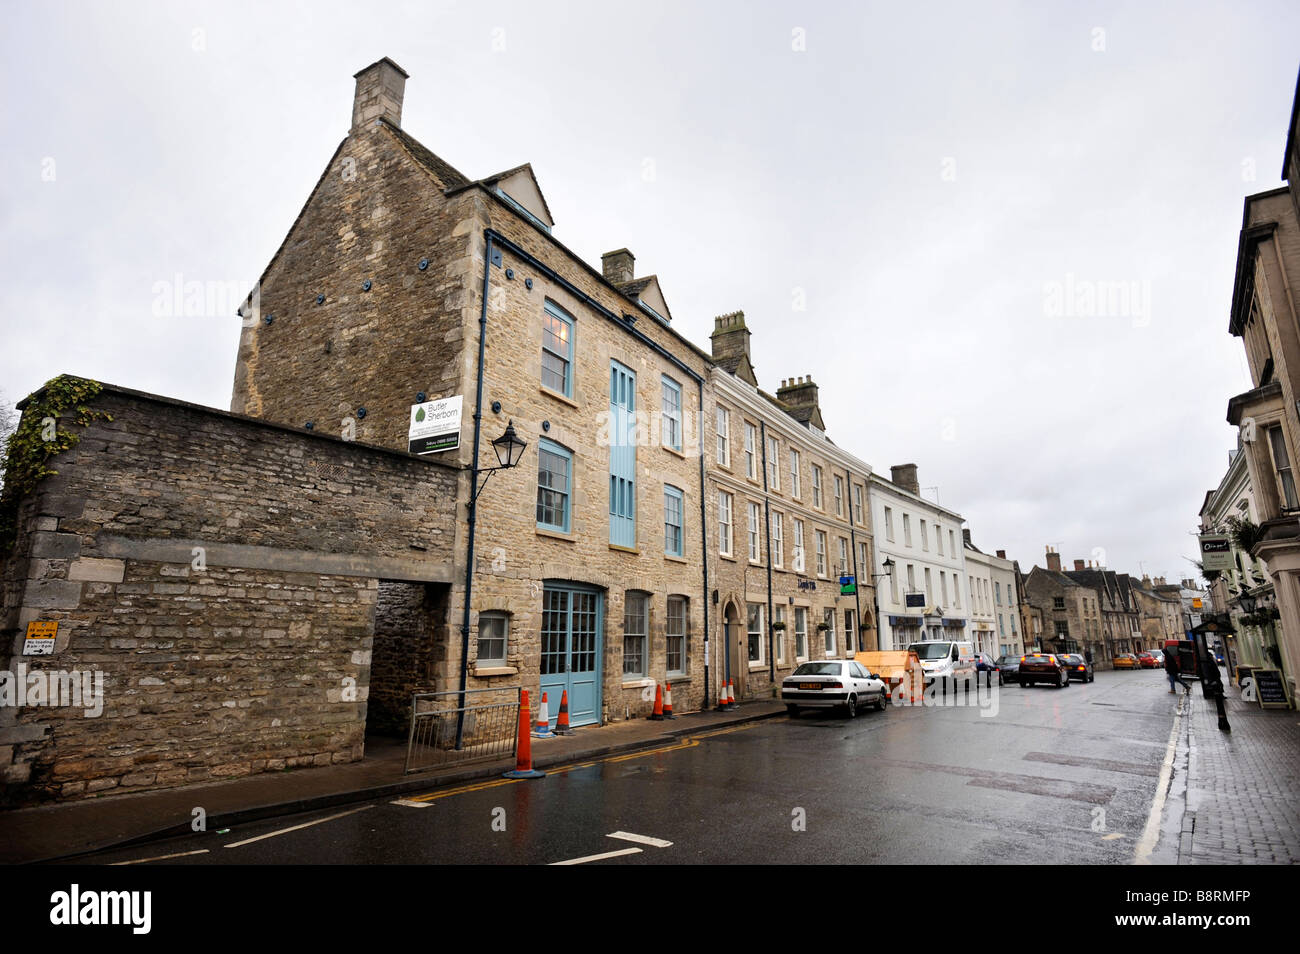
[867,464,970,650]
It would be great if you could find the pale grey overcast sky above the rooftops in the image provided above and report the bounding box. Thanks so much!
[0,0,1300,578]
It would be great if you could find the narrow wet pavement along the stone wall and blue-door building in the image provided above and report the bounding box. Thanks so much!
[0,701,785,864]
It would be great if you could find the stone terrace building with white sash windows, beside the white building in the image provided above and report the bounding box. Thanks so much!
[707,312,879,698]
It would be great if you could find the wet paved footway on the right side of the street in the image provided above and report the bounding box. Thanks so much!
[1175,685,1300,864]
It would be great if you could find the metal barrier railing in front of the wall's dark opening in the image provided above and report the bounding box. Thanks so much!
[406,686,523,775]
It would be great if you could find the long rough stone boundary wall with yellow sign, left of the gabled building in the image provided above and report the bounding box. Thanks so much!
[0,387,458,801]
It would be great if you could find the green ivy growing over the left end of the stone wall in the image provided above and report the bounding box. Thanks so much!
[0,374,113,555]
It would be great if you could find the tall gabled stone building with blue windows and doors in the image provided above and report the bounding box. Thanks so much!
[233,60,728,725]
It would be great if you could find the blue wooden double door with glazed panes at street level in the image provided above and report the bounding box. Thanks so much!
[541,584,602,725]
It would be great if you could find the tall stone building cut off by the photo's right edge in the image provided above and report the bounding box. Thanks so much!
[1227,70,1300,699]
